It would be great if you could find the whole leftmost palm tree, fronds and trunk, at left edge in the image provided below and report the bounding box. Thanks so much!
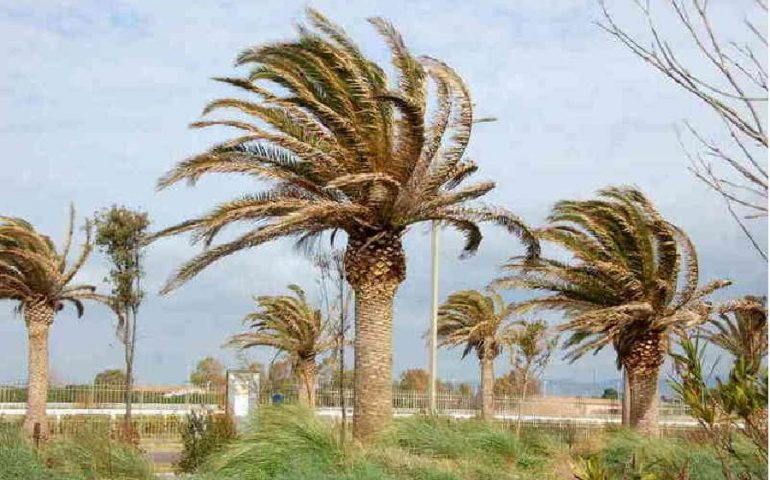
[0,208,119,438]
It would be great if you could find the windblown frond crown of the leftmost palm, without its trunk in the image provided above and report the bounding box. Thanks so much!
[0,208,117,316]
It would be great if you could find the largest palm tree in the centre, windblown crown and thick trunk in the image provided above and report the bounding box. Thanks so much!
[153,10,538,439]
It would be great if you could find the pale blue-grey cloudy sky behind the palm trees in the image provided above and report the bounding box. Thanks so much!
[0,0,767,390]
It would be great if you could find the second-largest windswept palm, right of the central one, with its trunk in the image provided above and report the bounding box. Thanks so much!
[496,187,729,435]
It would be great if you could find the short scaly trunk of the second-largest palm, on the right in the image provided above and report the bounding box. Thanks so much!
[622,332,666,437]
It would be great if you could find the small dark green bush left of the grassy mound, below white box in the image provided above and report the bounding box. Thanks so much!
[179,412,237,473]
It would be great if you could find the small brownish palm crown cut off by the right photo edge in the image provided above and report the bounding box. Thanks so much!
[705,295,767,374]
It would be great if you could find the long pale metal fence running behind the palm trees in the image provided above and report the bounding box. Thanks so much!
[0,383,694,442]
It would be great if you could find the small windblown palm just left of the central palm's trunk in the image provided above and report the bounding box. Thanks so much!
[229,285,337,407]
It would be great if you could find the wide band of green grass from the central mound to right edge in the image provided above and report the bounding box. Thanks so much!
[183,405,767,480]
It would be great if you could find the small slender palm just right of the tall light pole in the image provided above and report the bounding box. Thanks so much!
[438,290,511,419]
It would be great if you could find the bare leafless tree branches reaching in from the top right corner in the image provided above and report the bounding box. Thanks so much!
[599,0,768,261]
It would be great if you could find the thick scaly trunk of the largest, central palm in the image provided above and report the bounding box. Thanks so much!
[345,232,406,441]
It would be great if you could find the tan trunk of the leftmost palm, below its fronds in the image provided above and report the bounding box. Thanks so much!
[23,302,54,440]
